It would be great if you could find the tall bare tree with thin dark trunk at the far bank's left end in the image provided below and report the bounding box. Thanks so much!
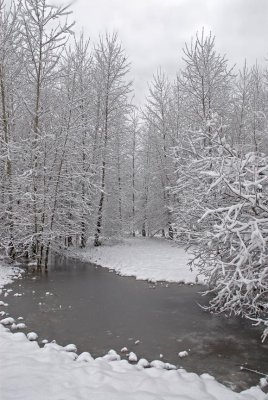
[94,34,130,246]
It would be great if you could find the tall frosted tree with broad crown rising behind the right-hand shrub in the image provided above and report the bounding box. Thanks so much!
[173,31,233,241]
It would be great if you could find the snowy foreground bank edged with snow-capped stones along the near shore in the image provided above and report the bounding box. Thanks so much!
[0,256,268,400]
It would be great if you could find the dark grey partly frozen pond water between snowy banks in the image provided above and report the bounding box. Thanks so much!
[1,259,268,390]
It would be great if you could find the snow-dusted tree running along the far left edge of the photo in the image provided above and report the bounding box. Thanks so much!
[0,0,20,257]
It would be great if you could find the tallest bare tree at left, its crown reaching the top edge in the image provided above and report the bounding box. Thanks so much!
[19,0,73,265]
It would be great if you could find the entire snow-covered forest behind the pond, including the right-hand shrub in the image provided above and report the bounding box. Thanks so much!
[0,0,268,338]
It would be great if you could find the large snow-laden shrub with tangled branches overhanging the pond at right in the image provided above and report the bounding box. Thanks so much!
[188,129,268,339]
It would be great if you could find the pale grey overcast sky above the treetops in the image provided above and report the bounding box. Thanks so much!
[71,0,268,101]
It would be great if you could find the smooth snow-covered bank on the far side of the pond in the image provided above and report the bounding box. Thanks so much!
[73,238,204,283]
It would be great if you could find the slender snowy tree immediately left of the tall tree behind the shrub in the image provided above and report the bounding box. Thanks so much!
[143,70,178,239]
